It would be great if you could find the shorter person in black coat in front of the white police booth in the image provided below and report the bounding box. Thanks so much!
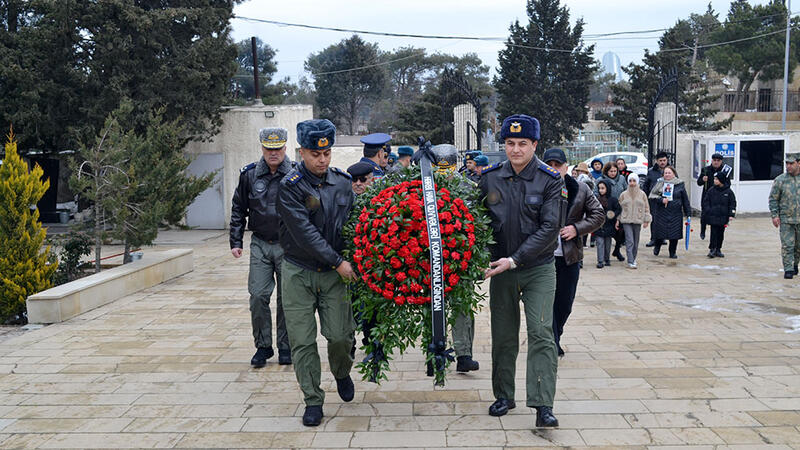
[702,171,736,258]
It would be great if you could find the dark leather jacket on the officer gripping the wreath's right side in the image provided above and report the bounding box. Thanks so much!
[479,157,567,268]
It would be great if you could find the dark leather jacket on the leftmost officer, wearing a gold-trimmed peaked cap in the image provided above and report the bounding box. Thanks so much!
[230,158,295,248]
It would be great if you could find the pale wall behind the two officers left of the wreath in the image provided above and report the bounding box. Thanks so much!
[184,105,313,227]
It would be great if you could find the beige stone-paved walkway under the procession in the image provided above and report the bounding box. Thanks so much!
[0,218,800,449]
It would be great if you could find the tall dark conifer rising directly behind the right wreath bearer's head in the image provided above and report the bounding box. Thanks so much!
[494,0,596,148]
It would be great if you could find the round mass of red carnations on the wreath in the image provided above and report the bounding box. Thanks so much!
[353,180,475,305]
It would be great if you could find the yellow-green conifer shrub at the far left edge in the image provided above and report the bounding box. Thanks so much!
[0,125,57,318]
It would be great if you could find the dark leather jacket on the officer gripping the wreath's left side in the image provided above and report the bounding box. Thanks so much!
[278,163,355,272]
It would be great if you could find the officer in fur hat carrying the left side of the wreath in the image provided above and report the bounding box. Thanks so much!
[278,119,355,426]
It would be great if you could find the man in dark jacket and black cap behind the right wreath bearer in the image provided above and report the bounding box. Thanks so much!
[542,148,606,356]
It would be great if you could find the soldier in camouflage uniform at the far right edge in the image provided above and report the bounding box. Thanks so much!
[769,153,800,279]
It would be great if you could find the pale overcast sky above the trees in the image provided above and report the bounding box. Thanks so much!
[233,0,766,81]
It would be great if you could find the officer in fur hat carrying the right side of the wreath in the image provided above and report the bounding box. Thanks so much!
[479,114,567,427]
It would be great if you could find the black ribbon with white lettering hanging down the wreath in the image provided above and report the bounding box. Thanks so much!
[419,142,454,385]
